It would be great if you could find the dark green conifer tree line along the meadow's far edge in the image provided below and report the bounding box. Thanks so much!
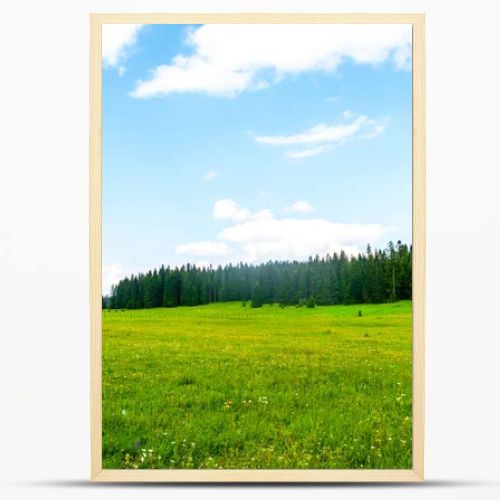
[103,241,412,309]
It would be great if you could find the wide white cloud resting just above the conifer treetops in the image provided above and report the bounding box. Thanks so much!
[219,218,384,262]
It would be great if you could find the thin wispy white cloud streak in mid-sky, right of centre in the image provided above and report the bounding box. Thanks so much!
[255,111,388,160]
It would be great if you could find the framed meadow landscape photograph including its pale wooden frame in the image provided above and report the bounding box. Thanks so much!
[90,14,425,482]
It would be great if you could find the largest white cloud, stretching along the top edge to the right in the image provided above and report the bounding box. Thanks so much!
[131,24,412,98]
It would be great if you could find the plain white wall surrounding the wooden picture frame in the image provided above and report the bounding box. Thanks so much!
[0,0,500,499]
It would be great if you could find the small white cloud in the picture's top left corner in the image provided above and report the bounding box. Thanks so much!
[102,24,143,68]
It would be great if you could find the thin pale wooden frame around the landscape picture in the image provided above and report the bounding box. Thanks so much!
[89,13,425,483]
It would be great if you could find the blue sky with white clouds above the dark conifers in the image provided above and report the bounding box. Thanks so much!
[103,25,412,293]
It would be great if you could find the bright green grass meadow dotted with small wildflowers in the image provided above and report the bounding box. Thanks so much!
[103,302,412,469]
